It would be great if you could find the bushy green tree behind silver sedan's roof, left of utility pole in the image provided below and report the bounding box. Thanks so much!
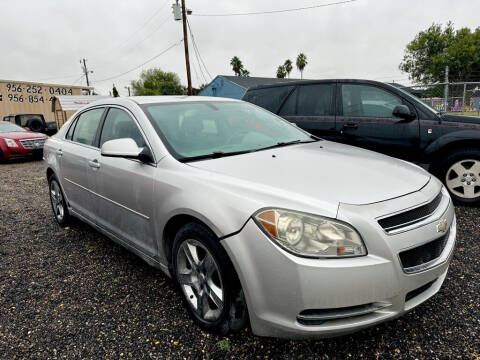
[131,68,185,96]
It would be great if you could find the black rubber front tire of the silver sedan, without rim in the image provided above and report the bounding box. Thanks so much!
[172,222,248,335]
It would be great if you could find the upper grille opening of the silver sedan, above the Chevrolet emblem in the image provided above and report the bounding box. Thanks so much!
[378,191,443,232]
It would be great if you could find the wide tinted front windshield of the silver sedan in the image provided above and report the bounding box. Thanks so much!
[143,101,315,160]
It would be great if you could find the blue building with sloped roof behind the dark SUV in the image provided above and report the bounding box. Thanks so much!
[198,75,300,99]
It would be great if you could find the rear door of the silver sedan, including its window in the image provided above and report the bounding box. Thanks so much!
[57,107,105,221]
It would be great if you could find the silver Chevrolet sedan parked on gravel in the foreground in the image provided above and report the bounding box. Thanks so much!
[44,97,456,338]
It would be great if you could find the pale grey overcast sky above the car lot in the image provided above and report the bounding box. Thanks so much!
[0,0,480,95]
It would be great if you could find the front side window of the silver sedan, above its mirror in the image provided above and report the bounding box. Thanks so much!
[100,108,146,147]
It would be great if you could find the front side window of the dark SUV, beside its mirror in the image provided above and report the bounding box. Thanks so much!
[342,85,402,118]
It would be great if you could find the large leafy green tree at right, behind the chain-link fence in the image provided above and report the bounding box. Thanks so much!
[399,22,480,84]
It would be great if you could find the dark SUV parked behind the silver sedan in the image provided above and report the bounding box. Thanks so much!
[243,80,480,204]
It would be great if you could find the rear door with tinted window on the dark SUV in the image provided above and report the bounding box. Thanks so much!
[278,83,337,139]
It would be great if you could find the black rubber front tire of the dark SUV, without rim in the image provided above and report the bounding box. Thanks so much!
[432,148,480,205]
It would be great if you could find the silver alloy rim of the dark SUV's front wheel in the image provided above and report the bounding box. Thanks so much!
[445,159,480,199]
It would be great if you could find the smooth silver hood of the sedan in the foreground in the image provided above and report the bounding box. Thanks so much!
[189,141,430,205]
